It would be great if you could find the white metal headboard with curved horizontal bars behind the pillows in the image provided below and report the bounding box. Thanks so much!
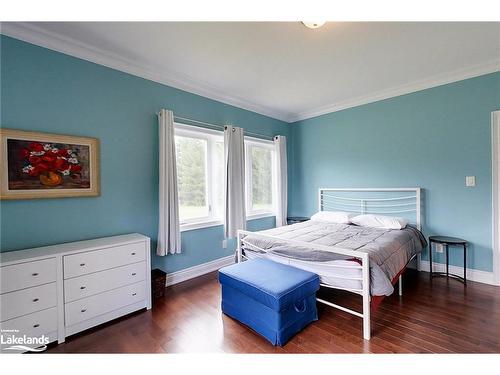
[318,188,422,230]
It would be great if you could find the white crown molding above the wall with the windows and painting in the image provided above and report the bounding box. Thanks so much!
[0,22,291,121]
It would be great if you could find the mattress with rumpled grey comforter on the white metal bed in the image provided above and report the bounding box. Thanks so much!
[243,220,426,296]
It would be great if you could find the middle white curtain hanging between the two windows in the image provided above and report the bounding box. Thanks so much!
[224,126,246,238]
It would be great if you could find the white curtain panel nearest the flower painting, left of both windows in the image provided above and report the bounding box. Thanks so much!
[156,109,181,255]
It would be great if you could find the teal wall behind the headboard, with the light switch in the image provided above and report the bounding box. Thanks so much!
[289,73,500,271]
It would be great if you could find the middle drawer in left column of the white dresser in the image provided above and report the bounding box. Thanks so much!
[0,283,57,322]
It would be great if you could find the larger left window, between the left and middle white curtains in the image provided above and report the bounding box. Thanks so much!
[175,124,224,229]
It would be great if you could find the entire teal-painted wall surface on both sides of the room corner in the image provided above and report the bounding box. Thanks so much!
[0,36,500,272]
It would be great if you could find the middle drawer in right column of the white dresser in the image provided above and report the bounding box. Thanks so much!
[64,262,146,303]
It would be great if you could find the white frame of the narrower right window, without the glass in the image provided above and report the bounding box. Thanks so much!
[245,136,278,220]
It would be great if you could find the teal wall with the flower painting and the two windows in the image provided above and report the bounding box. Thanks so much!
[0,36,290,272]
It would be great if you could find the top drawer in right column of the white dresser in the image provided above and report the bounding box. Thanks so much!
[64,242,146,279]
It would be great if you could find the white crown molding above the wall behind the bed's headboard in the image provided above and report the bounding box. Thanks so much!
[286,59,500,122]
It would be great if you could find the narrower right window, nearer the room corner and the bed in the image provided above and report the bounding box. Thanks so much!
[245,138,277,216]
